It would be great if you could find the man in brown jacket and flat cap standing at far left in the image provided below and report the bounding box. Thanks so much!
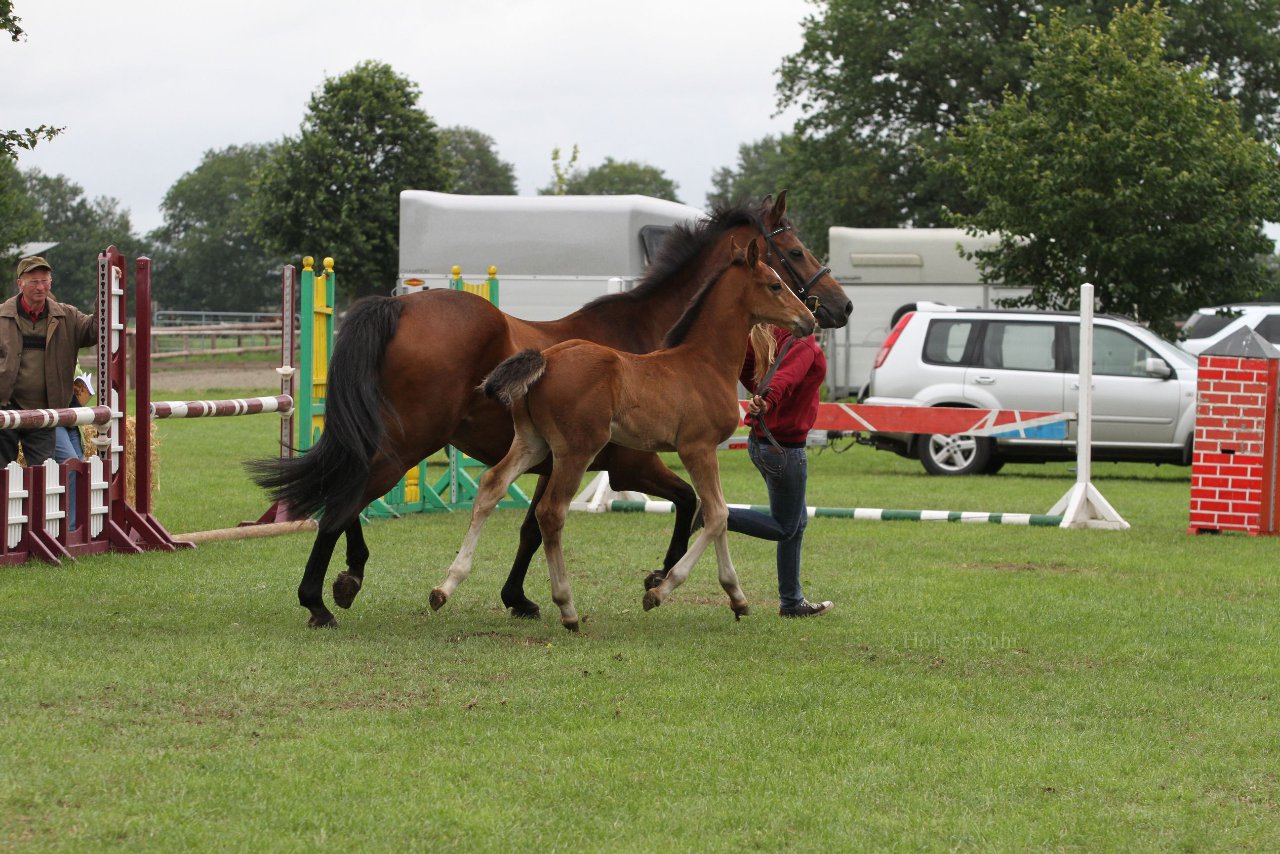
[0,255,97,466]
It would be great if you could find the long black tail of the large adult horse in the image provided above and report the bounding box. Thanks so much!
[246,296,403,533]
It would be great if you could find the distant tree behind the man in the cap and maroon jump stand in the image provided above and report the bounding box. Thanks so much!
[24,169,150,311]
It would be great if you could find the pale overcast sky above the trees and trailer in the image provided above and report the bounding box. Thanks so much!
[0,0,812,232]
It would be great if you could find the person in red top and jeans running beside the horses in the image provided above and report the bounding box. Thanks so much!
[728,324,833,617]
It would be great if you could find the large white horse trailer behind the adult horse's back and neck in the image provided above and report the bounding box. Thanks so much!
[396,189,705,320]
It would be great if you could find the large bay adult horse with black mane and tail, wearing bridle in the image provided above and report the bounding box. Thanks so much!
[248,191,852,626]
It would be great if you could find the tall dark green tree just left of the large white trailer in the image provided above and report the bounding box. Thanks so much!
[251,61,452,300]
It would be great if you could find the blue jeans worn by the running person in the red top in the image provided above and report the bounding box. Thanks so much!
[728,434,809,608]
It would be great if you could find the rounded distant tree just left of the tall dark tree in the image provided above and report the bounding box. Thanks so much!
[148,145,280,311]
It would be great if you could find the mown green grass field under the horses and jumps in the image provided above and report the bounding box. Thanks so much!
[0,389,1280,851]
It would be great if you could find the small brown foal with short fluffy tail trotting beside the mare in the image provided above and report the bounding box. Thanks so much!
[431,239,817,631]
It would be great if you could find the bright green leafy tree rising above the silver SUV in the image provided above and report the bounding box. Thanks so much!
[934,5,1280,334]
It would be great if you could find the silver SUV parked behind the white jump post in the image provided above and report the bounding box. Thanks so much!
[860,302,1196,475]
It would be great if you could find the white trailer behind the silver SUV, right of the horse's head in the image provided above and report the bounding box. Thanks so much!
[826,225,1027,397]
